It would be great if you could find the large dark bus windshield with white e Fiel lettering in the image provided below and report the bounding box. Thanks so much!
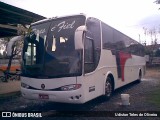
[22,16,85,78]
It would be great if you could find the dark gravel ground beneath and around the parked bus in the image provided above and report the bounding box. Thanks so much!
[0,78,160,119]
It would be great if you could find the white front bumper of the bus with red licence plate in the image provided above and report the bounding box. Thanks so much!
[21,87,84,104]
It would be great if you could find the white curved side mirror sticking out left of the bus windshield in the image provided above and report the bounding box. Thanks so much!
[7,36,22,56]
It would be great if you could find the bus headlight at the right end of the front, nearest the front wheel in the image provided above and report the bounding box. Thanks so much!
[61,84,81,91]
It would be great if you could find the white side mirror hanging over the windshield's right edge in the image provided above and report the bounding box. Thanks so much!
[74,26,86,50]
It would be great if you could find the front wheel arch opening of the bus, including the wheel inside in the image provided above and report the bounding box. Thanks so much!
[104,73,114,99]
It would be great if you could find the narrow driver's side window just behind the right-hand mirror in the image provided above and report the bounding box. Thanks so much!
[84,31,95,73]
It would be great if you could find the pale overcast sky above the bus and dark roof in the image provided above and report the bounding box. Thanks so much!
[0,0,160,44]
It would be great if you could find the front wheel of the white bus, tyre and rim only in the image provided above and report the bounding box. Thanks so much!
[105,77,113,99]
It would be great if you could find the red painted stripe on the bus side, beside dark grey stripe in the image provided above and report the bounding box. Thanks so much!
[119,52,132,81]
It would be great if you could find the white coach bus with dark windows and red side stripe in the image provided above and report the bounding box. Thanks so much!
[21,14,145,104]
